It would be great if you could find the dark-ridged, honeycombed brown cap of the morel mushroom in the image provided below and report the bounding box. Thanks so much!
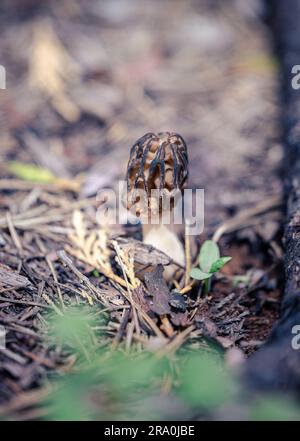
[126,132,188,217]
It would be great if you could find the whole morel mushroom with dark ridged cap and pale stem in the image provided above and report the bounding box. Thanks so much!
[126,132,188,277]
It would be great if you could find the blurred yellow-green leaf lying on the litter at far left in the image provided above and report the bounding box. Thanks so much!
[8,161,56,184]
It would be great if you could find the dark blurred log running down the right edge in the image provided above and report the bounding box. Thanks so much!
[246,0,300,395]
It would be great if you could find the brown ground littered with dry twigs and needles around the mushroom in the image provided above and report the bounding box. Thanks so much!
[0,0,282,418]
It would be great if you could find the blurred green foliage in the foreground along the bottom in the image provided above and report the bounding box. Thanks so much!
[45,307,297,421]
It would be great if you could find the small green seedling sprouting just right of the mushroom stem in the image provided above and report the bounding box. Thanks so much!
[190,240,231,294]
